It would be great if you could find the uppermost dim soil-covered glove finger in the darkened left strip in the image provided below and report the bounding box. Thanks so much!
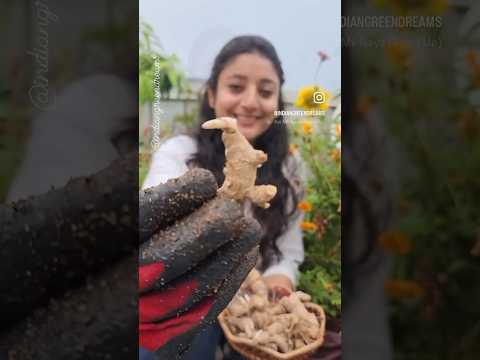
[0,153,138,332]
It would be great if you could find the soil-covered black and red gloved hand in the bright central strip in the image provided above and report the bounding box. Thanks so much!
[139,169,260,359]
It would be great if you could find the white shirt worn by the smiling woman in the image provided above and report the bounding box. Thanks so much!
[142,135,305,284]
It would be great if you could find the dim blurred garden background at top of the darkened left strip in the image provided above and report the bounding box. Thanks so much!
[0,0,138,202]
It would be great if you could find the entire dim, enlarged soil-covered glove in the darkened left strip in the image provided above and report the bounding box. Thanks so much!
[0,153,139,360]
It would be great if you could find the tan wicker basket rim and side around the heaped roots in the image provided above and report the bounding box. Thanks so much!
[218,303,326,360]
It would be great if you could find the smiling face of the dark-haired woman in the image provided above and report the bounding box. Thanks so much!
[208,53,280,142]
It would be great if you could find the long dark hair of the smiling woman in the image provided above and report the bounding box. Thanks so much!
[191,36,298,268]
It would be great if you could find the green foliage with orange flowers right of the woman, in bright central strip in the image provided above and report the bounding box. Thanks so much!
[290,115,341,317]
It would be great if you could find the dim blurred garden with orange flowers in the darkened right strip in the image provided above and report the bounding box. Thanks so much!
[344,0,480,360]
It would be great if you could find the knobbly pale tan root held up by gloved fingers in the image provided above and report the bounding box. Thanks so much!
[202,117,277,209]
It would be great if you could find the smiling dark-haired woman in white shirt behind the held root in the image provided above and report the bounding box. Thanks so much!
[143,36,304,360]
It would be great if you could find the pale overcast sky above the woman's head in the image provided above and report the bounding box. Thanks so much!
[140,0,341,92]
